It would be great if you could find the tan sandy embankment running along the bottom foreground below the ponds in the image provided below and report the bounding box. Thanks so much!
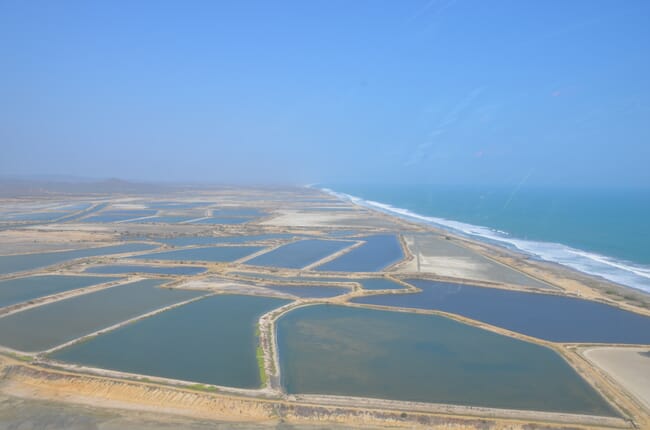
[0,358,629,430]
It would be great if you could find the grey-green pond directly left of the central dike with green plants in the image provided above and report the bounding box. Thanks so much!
[52,295,288,388]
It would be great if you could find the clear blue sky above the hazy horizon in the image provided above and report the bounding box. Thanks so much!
[0,0,650,187]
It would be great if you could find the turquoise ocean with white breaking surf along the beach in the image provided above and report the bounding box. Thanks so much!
[321,185,650,292]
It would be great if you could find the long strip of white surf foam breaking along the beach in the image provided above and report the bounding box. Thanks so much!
[322,188,650,292]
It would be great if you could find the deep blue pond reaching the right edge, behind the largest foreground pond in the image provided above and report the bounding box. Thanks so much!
[353,279,650,344]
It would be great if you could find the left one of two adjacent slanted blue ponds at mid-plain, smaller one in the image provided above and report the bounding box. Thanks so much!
[246,239,354,269]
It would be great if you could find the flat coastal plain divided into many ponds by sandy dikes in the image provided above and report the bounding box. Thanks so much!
[0,188,650,429]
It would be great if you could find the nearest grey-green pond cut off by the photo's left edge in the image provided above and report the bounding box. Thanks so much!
[0,279,205,351]
